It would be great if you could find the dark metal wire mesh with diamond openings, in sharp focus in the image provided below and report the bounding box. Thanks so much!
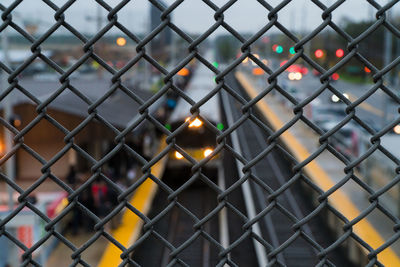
[0,0,400,266]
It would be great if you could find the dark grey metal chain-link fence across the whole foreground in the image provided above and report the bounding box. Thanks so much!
[0,0,400,266]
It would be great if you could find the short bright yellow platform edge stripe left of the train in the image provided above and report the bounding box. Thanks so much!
[97,138,167,267]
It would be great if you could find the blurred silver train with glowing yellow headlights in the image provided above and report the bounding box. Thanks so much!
[168,61,223,167]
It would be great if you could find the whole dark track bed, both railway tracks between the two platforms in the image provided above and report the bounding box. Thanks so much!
[132,73,352,267]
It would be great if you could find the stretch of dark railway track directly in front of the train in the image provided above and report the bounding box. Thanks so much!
[131,168,256,267]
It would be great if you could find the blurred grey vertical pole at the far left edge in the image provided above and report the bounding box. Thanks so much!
[1,29,15,211]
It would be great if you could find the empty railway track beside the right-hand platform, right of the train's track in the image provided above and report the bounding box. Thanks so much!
[222,75,351,266]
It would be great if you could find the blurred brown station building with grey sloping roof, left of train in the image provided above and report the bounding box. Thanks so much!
[0,78,155,180]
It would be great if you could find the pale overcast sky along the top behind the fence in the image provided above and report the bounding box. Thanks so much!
[1,0,394,36]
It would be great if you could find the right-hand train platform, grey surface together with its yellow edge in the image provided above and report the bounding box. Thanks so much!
[235,71,400,266]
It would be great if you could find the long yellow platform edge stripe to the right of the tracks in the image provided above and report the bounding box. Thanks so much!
[235,72,400,266]
